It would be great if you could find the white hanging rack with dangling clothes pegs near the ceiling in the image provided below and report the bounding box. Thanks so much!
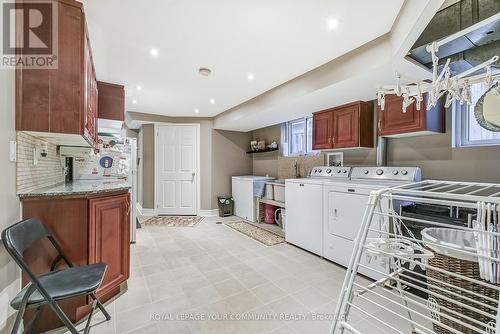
[377,13,500,113]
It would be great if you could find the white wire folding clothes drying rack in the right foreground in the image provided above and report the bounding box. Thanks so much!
[330,180,500,334]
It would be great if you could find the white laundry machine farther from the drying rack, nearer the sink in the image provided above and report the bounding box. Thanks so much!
[285,167,351,256]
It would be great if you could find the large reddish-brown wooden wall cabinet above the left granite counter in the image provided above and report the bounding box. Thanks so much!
[16,0,97,146]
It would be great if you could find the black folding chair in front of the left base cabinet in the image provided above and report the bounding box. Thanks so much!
[2,218,111,334]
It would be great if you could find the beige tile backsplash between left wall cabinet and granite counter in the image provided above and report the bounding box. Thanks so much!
[16,131,64,193]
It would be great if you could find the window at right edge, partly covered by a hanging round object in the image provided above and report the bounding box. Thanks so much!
[453,83,500,147]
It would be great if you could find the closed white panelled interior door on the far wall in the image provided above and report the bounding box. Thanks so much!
[156,125,198,215]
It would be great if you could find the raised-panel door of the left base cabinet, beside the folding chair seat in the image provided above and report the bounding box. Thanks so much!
[89,194,130,299]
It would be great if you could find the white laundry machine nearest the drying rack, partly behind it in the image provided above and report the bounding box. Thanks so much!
[323,167,421,280]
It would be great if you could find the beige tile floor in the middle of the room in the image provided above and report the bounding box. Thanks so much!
[74,217,424,334]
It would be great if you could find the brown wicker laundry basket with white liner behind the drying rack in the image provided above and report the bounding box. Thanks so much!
[422,228,498,334]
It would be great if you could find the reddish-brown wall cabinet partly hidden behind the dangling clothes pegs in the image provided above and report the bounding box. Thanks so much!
[377,95,445,137]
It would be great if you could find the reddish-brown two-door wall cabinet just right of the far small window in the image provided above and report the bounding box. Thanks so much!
[313,101,374,150]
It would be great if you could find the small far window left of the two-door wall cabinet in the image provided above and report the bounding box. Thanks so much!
[281,117,317,156]
